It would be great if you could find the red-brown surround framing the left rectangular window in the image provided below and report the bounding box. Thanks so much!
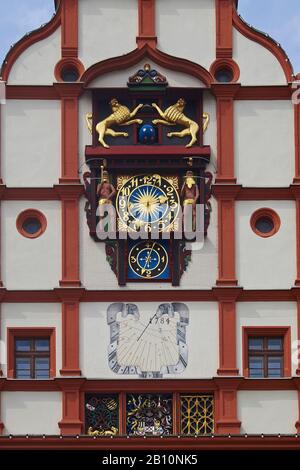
[7,327,56,379]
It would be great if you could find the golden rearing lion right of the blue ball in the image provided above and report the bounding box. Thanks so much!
[152,98,209,147]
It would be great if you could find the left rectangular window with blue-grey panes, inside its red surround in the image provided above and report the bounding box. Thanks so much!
[15,337,50,379]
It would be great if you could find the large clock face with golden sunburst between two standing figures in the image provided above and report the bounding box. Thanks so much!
[116,174,180,232]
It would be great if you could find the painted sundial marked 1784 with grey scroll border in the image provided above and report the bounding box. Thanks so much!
[107,302,189,378]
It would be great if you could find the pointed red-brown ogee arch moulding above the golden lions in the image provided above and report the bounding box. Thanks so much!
[81,44,214,87]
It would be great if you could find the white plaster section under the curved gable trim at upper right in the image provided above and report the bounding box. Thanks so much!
[233,28,286,85]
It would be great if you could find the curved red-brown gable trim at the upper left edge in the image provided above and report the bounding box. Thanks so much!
[1,4,62,82]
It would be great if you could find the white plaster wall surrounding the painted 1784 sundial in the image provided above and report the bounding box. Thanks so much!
[80,298,219,379]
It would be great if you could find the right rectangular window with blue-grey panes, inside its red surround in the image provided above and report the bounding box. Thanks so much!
[248,336,284,378]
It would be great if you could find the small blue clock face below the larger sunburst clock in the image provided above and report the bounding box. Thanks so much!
[128,240,170,280]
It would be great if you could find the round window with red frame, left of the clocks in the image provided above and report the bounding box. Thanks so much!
[16,209,47,238]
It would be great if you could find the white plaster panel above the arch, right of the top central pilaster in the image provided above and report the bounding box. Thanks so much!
[156,0,216,69]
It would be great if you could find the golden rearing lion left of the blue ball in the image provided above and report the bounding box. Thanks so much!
[86,98,143,148]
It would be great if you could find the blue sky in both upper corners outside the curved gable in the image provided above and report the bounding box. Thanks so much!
[0,0,300,73]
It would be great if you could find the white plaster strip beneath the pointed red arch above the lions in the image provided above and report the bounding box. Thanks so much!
[85,57,205,88]
